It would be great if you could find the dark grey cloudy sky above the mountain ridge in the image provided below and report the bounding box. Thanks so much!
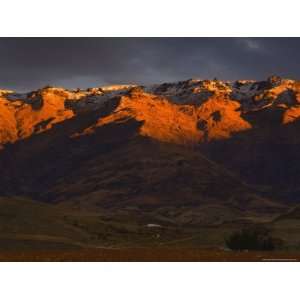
[0,38,300,90]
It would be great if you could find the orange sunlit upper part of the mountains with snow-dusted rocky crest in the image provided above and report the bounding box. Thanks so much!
[0,76,300,145]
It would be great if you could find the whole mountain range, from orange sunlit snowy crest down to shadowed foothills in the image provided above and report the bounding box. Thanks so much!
[0,76,300,249]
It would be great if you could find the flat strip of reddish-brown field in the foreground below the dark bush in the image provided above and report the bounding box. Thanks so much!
[0,248,300,262]
